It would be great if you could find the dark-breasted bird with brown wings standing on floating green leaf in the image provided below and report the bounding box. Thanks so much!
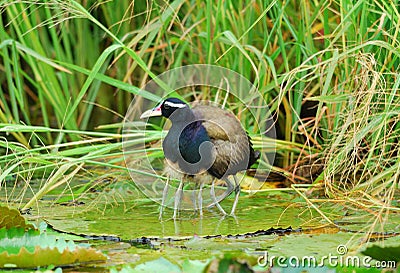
[140,97,260,219]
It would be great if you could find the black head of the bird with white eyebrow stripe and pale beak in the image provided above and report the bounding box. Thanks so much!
[140,98,190,118]
